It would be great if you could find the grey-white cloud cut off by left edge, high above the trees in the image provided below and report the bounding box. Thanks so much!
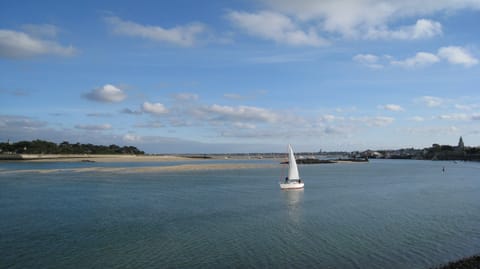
[0,29,77,59]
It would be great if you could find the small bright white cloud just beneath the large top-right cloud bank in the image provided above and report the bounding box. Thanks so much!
[365,19,442,40]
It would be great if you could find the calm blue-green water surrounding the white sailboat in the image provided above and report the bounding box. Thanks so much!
[0,161,480,268]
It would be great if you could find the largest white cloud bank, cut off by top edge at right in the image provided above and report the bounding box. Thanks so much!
[263,0,480,39]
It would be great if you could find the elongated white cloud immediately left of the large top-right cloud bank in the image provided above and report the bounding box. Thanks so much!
[227,11,328,46]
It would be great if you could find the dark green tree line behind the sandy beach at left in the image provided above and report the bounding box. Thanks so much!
[0,139,145,155]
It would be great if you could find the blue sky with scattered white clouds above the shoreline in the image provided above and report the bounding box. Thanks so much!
[0,0,480,153]
